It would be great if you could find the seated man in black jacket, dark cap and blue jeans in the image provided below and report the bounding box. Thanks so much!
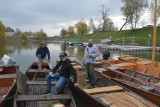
[45,53,78,94]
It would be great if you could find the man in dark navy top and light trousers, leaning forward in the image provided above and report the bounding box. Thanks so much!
[36,42,52,69]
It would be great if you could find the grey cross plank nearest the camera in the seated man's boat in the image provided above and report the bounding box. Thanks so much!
[16,94,72,101]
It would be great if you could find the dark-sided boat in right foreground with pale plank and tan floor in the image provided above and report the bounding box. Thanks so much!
[70,62,156,107]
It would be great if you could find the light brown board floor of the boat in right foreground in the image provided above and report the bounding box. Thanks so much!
[99,92,154,107]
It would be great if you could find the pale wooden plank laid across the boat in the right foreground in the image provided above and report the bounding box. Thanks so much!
[84,86,123,94]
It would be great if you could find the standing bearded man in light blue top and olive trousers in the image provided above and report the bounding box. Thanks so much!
[84,39,99,87]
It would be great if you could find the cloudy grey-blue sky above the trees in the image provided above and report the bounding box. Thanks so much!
[0,0,154,36]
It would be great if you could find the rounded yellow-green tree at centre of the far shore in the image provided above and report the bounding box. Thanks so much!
[75,21,88,35]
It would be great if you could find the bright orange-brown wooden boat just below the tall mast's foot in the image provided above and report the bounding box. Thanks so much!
[101,59,160,79]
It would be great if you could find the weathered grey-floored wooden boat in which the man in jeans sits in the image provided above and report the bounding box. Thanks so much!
[14,62,76,107]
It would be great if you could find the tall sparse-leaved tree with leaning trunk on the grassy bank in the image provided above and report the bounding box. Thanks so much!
[120,0,148,30]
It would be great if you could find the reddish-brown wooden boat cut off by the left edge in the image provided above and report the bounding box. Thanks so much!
[0,66,19,107]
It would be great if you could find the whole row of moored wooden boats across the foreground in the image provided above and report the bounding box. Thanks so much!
[0,56,160,107]
